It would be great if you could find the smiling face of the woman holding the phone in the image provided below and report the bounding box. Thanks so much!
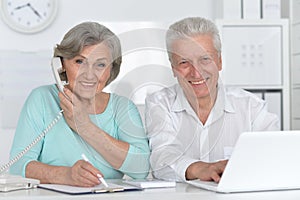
[63,43,112,99]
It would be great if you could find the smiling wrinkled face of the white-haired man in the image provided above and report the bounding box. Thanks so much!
[171,35,222,100]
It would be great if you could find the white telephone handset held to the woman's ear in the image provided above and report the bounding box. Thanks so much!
[51,57,69,93]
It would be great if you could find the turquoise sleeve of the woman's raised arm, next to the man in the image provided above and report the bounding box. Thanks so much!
[116,96,150,179]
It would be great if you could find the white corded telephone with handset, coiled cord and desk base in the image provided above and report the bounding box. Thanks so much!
[0,57,68,192]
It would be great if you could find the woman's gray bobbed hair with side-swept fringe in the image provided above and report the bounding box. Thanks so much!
[54,22,122,85]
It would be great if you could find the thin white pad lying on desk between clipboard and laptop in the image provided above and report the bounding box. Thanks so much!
[124,179,176,189]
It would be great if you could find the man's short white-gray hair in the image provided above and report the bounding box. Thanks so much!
[166,17,222,59]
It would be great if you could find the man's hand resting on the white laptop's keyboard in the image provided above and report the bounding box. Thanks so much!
[185,160,228,183]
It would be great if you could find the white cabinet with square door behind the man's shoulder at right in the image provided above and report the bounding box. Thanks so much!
[216,19,290,130]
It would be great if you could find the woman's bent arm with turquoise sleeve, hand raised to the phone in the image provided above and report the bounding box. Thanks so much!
[59,89,150,178]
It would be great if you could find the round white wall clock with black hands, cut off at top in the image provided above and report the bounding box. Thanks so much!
[1,0,58,33]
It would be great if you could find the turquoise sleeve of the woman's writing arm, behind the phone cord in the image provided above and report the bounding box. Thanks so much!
[10,87,59,176]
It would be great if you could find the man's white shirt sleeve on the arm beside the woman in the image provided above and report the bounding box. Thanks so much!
[145,96,198,182]
